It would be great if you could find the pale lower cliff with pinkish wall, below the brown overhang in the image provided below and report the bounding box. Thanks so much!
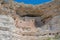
[0,15,60,40]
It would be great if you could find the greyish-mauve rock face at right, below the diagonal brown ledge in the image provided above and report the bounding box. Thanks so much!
[41,15,60,34]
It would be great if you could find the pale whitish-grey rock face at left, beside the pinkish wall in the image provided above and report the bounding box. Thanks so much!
[0,15,20,40]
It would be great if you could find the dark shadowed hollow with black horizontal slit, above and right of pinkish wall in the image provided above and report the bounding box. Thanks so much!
[21,14,43,27]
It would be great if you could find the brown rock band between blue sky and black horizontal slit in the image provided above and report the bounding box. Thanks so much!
[17,1,59,18]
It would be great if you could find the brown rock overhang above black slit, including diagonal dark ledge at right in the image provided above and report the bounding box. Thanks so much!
[16,0,60,26]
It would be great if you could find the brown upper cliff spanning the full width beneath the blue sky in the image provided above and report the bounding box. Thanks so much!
[0,0,60,22]
